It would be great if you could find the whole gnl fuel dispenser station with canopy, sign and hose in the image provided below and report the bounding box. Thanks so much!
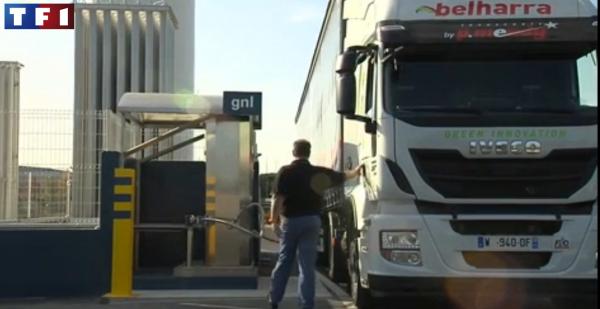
[108,92,274,295]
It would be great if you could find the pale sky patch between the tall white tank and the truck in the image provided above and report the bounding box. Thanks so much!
[195,0,327,171]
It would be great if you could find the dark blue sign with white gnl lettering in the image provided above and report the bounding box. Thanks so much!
[223,91,262,129]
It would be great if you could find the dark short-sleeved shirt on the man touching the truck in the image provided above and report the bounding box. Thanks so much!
[275,160,345,218]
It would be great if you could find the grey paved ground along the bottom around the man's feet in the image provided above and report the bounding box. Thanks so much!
[0,226,597,309]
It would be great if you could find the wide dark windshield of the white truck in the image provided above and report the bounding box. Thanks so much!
[385,60,597,114]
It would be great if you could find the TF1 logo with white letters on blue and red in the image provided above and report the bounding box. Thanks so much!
[4,3,75,30]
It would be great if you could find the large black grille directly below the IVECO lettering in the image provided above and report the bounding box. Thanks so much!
[411,149,598,198]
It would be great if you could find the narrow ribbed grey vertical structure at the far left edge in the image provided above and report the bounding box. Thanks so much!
[0,61,23,220]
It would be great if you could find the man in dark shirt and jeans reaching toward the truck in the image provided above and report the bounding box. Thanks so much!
[269,140,362,309]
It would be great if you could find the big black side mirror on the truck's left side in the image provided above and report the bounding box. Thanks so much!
[336,48,364,116]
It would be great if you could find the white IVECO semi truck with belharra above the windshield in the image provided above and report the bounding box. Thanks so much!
[296,0,598,308]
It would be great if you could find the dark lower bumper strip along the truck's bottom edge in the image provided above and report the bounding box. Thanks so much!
[369,275,598,298]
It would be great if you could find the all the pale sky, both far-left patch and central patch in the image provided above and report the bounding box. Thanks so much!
[0,0,597,171]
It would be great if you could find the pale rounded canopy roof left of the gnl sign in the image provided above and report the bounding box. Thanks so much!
[117,93,223,127]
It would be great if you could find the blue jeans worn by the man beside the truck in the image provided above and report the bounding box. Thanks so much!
[270,216,321,309]
